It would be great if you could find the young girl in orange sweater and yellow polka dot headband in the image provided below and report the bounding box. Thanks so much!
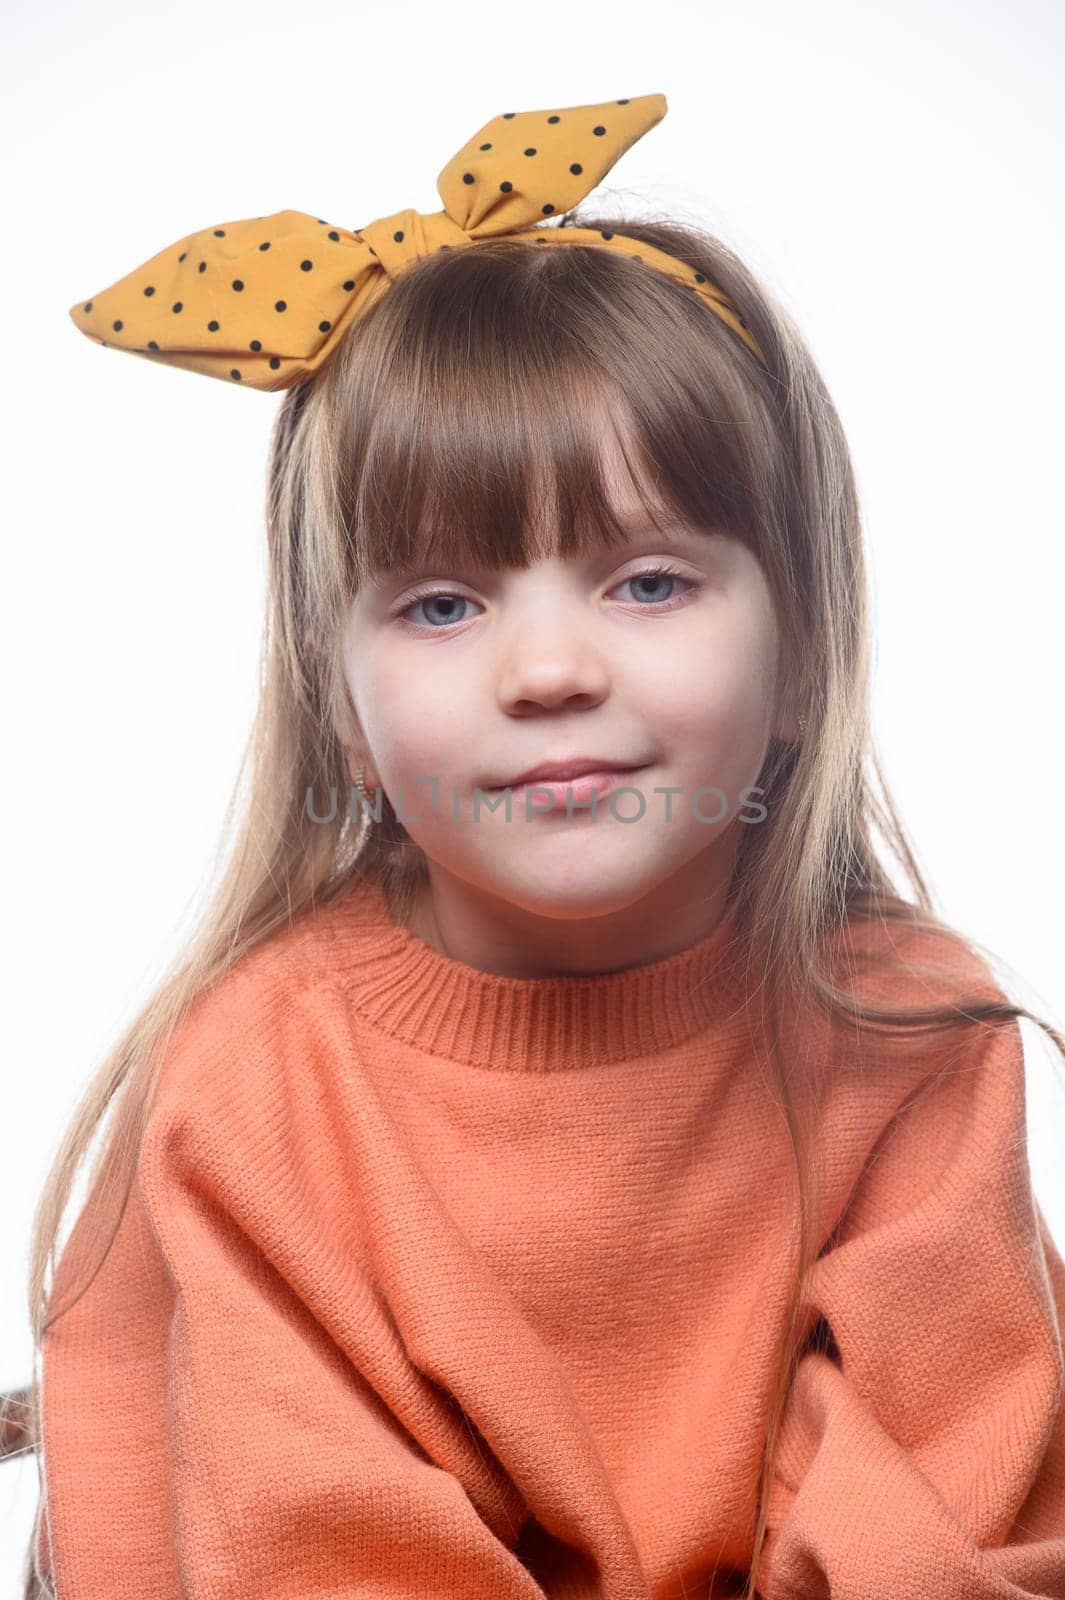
[20,94,1065,1600]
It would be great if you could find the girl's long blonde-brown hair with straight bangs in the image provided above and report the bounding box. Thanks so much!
[14,213,1065,1600]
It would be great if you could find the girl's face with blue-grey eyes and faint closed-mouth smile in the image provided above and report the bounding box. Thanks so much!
[344,425,788,974]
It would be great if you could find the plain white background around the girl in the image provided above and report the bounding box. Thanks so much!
[0,0,1065,1580]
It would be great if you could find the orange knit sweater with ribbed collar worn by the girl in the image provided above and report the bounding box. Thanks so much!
[37,885,1065,1600]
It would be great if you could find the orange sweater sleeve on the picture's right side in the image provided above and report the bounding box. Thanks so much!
[760,1019,1065,1600]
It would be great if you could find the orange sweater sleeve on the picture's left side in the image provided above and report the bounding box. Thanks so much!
[38,998,542,1600]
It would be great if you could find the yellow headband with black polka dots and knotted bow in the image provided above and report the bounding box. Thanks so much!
[70,94,764,389]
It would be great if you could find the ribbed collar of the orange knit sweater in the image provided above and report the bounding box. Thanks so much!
[299,880,745,1072]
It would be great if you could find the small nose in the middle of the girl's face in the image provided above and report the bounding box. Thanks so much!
[497,603,609,715]
